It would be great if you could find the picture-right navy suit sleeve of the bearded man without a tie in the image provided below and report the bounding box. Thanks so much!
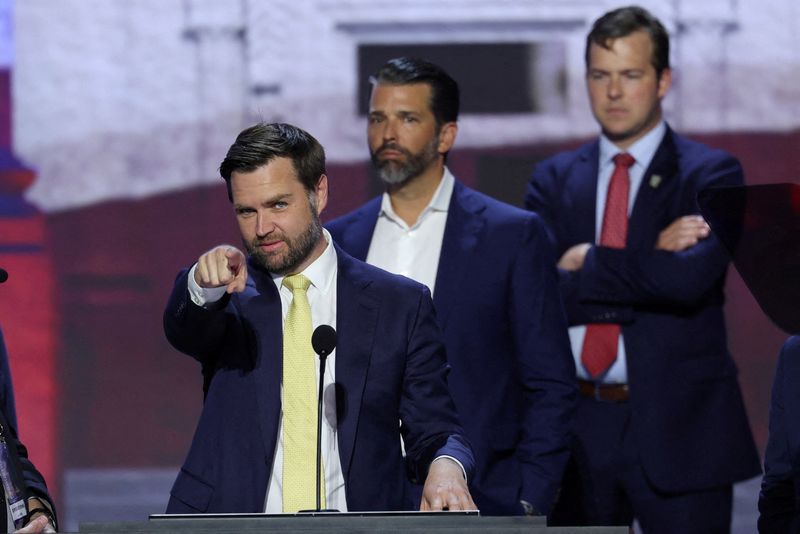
[510,217,576,513]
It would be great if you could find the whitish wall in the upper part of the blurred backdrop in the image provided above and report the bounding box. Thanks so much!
[6,0,800,211]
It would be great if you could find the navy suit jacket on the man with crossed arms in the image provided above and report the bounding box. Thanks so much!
[525,128,760,492]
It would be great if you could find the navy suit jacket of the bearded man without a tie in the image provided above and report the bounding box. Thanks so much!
[327,181,575,515]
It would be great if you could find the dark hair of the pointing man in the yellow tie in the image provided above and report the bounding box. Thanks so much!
[219,122,325,201]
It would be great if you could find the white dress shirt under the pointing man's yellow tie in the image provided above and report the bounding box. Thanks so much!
[189,229,347,514]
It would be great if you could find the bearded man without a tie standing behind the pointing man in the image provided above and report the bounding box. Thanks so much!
[327,58,575,515]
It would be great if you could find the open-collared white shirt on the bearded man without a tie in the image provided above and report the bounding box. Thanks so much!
[367,167,455,294]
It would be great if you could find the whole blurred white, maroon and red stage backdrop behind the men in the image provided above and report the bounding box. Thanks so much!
[6,0,800,532]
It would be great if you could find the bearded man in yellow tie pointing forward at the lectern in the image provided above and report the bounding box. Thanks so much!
[164,124,475,513]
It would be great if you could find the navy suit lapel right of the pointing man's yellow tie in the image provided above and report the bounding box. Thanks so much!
[336,247,379,483]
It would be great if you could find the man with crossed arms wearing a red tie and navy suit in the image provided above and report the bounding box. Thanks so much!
[526,7,759,534]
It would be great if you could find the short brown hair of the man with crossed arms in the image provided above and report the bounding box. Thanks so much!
[586,6,669,78]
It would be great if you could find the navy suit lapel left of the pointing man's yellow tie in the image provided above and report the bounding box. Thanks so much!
[242,264,283,461]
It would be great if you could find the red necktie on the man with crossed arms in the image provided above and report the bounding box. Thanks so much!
[581,152,636,379]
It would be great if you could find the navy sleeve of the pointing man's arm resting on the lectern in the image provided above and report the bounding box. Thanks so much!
[400,288,475,483]
